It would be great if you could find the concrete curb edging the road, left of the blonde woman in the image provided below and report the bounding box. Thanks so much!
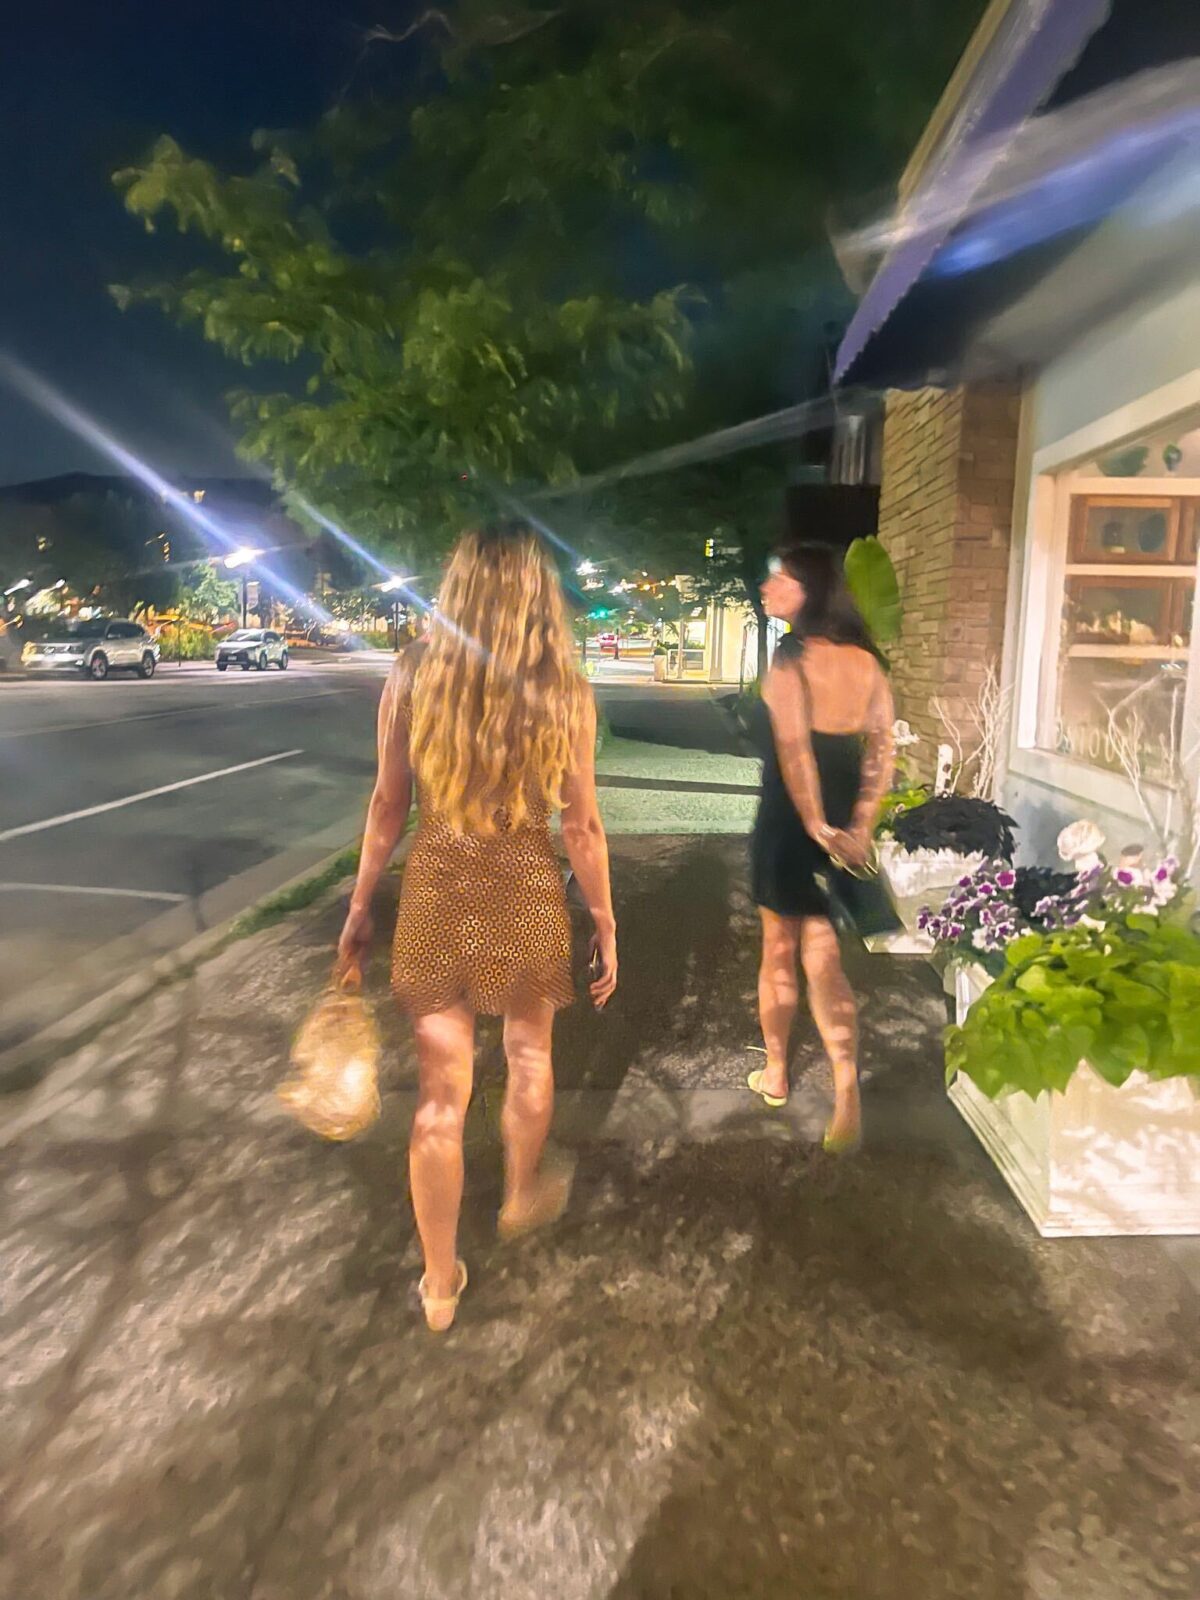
[0,842,361,1094]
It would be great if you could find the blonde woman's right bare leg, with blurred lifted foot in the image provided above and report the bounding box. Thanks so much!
[501,1000,570,1234]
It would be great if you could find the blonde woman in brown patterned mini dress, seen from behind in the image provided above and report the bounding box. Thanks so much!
[339,523,618,1331]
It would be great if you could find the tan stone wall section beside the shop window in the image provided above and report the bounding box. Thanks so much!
[878,382,1021,778]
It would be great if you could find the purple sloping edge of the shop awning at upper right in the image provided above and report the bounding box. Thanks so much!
[834,0,1110,384]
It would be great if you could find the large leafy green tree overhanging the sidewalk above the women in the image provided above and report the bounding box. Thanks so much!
[108,0,981,636]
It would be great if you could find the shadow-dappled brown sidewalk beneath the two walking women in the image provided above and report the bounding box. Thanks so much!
[0,835,1200,1600]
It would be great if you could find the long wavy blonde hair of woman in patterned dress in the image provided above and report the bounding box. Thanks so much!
[410,523,587,835]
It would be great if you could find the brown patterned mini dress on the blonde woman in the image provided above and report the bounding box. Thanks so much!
[392,653,574,1016]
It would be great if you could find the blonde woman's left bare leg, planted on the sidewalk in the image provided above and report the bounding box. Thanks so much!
[408,1005,475,1299]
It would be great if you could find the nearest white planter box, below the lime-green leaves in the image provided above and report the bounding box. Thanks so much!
[950,965,1200,1238]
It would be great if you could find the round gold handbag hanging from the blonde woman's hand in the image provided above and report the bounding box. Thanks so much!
[278,968,381,1141]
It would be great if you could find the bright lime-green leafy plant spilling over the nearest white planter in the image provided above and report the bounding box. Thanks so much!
[946,901,1200,1099]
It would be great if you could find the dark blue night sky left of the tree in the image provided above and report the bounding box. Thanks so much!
[0,0,382,483]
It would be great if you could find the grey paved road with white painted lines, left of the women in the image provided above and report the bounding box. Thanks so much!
[0,659,387,1048]
